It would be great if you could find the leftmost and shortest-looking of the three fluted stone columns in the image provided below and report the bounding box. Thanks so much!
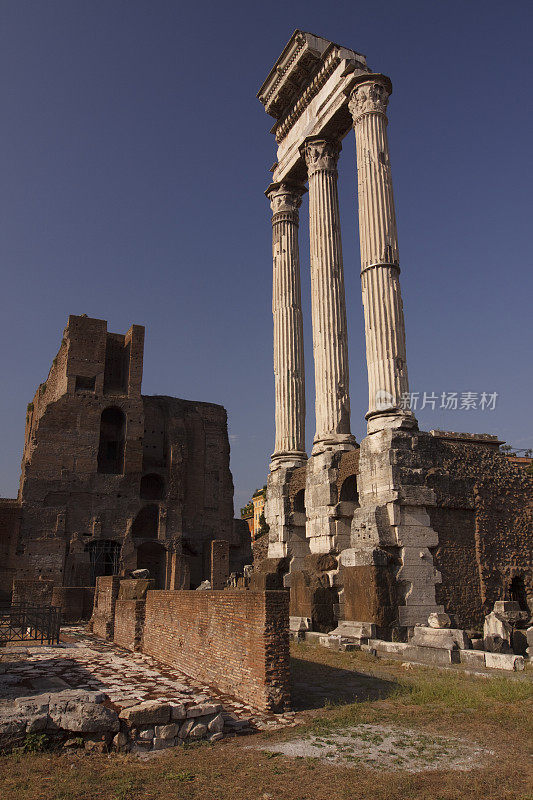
[266,183,307,467]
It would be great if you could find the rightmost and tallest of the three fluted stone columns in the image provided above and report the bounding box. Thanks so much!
[349,74,416,433]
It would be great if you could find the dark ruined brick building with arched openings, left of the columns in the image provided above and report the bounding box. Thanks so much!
[0,316,251,598]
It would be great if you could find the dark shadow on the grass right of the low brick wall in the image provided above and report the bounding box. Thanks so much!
[291,658,397,711]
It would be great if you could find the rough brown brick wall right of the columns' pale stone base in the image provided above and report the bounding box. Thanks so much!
[425,438,533,628]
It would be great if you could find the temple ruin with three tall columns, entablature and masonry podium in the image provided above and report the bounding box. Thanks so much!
[258,30,533,638]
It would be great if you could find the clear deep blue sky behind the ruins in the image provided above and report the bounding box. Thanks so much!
[0,0,533,510]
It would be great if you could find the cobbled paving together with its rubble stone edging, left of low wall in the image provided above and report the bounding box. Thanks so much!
[0,626,295,752]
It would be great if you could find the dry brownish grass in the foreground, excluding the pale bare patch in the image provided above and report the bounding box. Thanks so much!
[0,646,533,800]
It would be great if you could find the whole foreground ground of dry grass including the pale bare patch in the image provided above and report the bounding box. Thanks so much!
[0,645,533,800]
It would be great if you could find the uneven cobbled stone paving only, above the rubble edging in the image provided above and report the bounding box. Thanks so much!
[0,626,296,733]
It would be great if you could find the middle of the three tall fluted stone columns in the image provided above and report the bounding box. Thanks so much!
[302,138,355,453]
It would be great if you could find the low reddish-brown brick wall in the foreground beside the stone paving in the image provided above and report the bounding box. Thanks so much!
[142,591,290,712]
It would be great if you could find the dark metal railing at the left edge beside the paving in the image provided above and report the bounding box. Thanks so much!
[0,603,61,647]
